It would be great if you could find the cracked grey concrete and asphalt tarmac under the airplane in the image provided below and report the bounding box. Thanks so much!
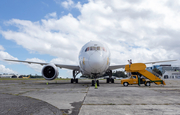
[0,79,180,115]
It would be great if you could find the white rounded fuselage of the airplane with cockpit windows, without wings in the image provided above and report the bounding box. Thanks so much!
[79,41,110,76]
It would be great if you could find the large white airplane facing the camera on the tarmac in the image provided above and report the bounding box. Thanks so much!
[4,41,176,86]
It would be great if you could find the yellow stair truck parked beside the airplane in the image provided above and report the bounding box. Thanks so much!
[121,63,166,86]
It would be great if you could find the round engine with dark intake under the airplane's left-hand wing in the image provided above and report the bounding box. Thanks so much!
[42,63,59,80]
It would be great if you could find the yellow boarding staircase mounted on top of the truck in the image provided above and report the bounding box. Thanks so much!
[125,63,166,86]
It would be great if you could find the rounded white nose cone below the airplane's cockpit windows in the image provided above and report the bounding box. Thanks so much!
[89,52,103,71]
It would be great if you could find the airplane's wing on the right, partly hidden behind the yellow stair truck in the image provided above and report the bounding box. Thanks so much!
[108,60,177,70]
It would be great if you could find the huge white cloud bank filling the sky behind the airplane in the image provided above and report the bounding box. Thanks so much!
[0,0,180,68]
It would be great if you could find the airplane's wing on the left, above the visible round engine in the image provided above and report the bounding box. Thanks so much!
[4,59,79,70]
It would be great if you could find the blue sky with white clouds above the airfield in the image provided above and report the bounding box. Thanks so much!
[0,0,180,78]
